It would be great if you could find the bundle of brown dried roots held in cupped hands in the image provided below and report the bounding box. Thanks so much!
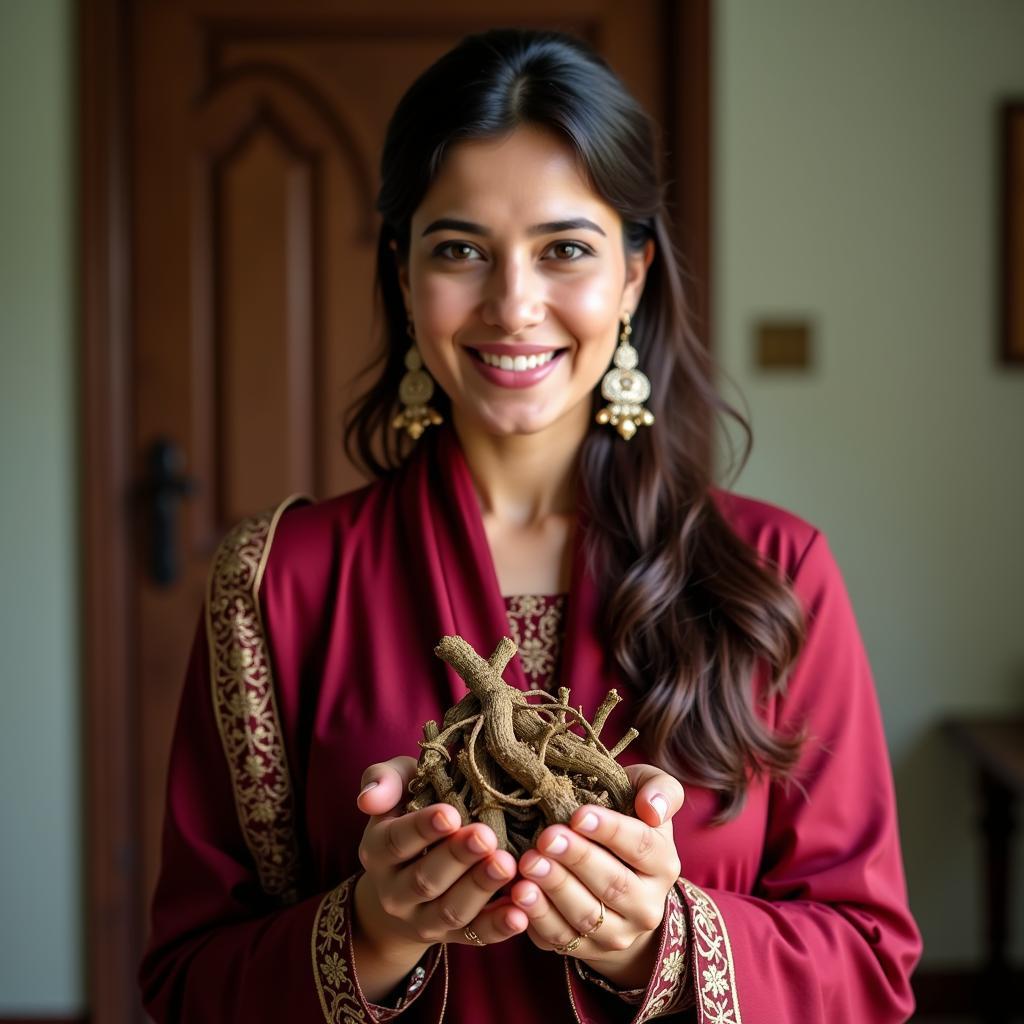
[406,636,638,856]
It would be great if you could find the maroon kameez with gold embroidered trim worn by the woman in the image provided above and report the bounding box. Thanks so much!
[141,428,920,1024]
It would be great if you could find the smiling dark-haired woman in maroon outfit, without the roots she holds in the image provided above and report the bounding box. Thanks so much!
[142,31,920,1024]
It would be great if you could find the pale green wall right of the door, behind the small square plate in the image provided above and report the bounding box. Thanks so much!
[714,0,1024,967]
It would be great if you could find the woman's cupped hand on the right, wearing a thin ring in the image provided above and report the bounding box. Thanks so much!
[510,765,683,987]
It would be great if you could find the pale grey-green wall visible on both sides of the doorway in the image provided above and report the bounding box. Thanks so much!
[0,0,1024,1016]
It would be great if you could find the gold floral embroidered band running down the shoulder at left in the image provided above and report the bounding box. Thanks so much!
[206,496,307,903]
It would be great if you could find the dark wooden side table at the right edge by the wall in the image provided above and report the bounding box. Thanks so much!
[945,716,1024,1024]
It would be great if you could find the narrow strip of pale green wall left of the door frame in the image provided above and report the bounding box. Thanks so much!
[0,0,84,1015]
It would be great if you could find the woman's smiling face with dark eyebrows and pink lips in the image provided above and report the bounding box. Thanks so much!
[399,127,653,440]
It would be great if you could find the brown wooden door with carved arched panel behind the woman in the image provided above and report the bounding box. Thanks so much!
[116,0,700,1019]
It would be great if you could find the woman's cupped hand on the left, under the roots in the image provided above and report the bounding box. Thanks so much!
[353,757,529,997]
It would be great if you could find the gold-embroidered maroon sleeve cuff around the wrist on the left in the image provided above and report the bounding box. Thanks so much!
[311,876,447,1024]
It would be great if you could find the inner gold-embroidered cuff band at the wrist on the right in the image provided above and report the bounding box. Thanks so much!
[565,886,696,1024]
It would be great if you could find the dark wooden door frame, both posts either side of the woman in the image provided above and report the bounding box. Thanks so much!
[77,0,713,1024]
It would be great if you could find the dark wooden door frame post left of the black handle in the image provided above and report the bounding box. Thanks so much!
[77,0,141,1024]
